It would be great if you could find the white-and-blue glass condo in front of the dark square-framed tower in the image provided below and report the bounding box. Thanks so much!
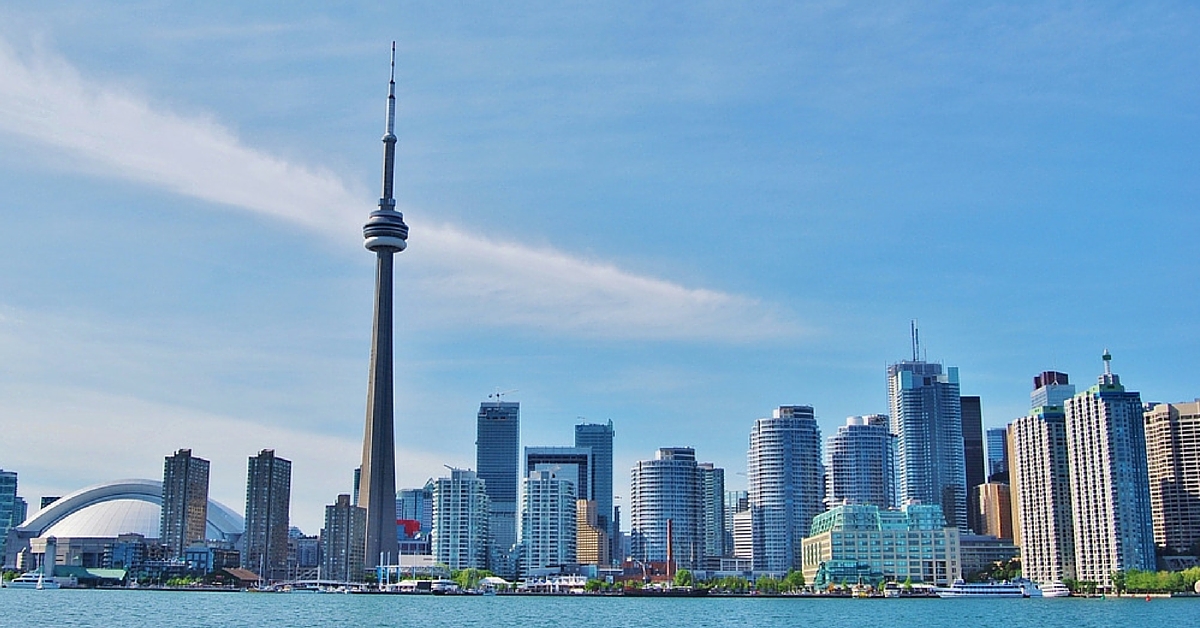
[520,471,578,574]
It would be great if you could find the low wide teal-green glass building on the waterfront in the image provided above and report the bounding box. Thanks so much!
[800,504,962,588]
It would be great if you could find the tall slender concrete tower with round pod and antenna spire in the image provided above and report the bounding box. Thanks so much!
[359,42,408,568]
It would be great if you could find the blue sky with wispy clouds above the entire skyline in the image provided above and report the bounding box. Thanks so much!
[0,1,1200,533]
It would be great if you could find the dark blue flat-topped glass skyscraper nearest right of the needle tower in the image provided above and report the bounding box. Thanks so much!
[475,401,521,576]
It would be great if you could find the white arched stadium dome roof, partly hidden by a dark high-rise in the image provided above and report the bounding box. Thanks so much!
[17,479,246,543]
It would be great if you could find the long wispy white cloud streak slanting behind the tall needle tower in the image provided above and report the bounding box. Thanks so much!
[0,40,799,342]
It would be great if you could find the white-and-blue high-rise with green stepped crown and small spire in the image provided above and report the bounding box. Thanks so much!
[1064,351,1154,587]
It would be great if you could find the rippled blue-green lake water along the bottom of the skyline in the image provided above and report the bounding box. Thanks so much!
[0,588,1200,628]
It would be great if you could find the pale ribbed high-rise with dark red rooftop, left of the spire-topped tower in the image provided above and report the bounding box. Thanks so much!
[1007,371,1075,582]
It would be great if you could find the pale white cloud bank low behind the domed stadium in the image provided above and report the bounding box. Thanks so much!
[0,384,443,534]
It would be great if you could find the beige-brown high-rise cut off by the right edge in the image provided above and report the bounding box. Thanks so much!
[1146,401,1200,556]
